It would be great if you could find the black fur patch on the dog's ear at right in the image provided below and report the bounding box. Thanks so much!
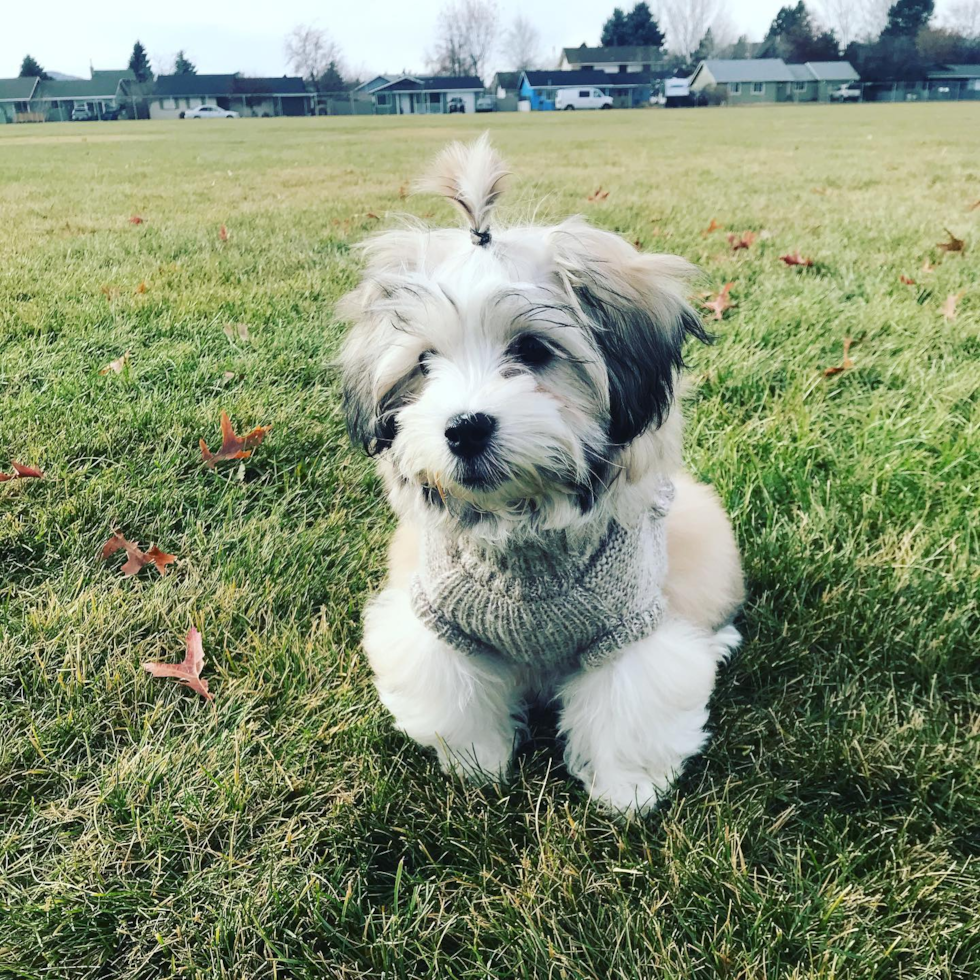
[576,286,711,445]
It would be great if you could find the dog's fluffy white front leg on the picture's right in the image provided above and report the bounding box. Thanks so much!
[559,620,741,814]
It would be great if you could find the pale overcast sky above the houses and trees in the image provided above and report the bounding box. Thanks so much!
[0,0,956,78]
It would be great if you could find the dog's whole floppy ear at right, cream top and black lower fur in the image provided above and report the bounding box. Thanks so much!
[551,219,711,445]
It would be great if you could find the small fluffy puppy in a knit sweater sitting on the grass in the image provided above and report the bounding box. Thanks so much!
[338,135,744,815]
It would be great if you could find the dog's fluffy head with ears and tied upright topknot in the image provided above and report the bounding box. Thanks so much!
[340,136,707,536]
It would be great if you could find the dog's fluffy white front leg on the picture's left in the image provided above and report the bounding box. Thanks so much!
[364,588,522,780]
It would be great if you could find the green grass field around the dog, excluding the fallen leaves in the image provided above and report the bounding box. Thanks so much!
[0,104,980,980]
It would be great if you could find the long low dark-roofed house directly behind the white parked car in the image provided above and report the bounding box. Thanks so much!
[147,72,312,119]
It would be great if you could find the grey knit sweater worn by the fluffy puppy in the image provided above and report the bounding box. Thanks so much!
[411,481,674,668]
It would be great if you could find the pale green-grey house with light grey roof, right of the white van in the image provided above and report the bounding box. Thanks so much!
[691,58,859,105]
